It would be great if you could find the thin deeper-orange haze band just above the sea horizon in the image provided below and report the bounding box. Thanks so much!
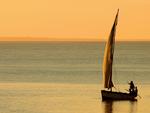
[0,36,150,42]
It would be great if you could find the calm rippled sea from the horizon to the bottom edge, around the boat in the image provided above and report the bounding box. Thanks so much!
[0,42,150,113]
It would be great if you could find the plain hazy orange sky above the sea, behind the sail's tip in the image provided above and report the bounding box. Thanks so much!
[0,0,150,41]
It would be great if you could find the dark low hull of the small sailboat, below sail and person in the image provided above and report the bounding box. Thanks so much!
[101,90,136,100]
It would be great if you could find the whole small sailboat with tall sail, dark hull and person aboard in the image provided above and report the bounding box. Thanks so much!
[101,9,138,100]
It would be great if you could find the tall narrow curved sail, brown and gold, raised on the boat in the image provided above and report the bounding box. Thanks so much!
[103,10,119,89]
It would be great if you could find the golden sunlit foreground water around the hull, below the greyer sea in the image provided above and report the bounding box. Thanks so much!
[0,83,150,113]
